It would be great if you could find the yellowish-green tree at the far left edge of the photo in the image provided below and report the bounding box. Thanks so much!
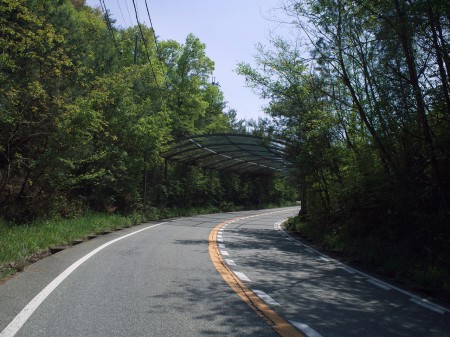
[0,0,81,218]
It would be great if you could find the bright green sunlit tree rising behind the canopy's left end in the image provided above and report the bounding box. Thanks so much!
[160,34,229,138]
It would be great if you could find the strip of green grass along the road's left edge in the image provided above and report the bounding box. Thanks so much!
[0,205,296,281]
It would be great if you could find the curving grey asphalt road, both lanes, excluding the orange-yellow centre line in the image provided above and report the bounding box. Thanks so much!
[0,208,450,337]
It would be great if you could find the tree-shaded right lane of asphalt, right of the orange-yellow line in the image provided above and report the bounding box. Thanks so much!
[209,227,450,337]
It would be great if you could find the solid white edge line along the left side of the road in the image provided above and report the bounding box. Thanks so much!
[0,222,166,337]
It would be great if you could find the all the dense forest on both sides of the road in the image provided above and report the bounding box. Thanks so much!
[0,0,450,298]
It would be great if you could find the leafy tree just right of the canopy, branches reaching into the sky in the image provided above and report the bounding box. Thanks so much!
[238,39,339,214]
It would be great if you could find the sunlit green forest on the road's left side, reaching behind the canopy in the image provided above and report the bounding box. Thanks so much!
[0,0,295,223]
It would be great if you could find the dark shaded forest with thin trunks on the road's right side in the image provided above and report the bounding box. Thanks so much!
[239,0,450,298]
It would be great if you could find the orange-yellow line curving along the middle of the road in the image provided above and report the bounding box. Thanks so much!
[208,218,306,337]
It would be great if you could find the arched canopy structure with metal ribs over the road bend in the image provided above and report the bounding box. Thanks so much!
[162,134,291,174]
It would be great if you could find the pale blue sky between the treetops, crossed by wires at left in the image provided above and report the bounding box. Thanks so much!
[86,0,286,120]
